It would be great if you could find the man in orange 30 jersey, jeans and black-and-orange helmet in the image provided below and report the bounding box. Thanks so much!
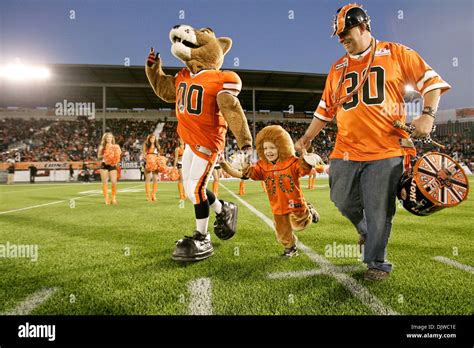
[296,4,450,280]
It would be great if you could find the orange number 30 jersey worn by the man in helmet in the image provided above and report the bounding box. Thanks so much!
[314,41,451,161]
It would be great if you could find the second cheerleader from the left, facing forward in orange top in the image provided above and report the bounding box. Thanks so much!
[143,134,161,202]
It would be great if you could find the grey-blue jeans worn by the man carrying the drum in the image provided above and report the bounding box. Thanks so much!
[329,157,403,272]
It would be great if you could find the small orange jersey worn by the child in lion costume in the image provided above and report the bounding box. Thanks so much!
[249,157,311,215]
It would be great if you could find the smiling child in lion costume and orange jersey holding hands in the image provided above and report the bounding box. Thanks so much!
[221,126,321,257]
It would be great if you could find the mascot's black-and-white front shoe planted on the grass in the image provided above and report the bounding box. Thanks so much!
[171,231,214,261]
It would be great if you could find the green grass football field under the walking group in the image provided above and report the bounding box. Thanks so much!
[0,178,474,315]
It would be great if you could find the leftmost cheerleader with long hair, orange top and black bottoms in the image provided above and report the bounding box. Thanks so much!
[98,132,122,205]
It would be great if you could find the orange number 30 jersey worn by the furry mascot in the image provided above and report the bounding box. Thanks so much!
[176,68,242,152]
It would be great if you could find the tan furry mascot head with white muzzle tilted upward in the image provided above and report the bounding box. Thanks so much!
[170,25,232,74]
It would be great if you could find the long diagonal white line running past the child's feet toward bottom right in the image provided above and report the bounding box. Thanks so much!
[221,184,398,315]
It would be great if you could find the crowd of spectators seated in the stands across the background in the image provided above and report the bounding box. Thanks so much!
[0,118,474,170]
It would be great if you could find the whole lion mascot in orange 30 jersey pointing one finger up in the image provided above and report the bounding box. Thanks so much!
[145,25,252,261]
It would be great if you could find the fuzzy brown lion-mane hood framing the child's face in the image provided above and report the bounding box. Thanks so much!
[257,126,295,162]
